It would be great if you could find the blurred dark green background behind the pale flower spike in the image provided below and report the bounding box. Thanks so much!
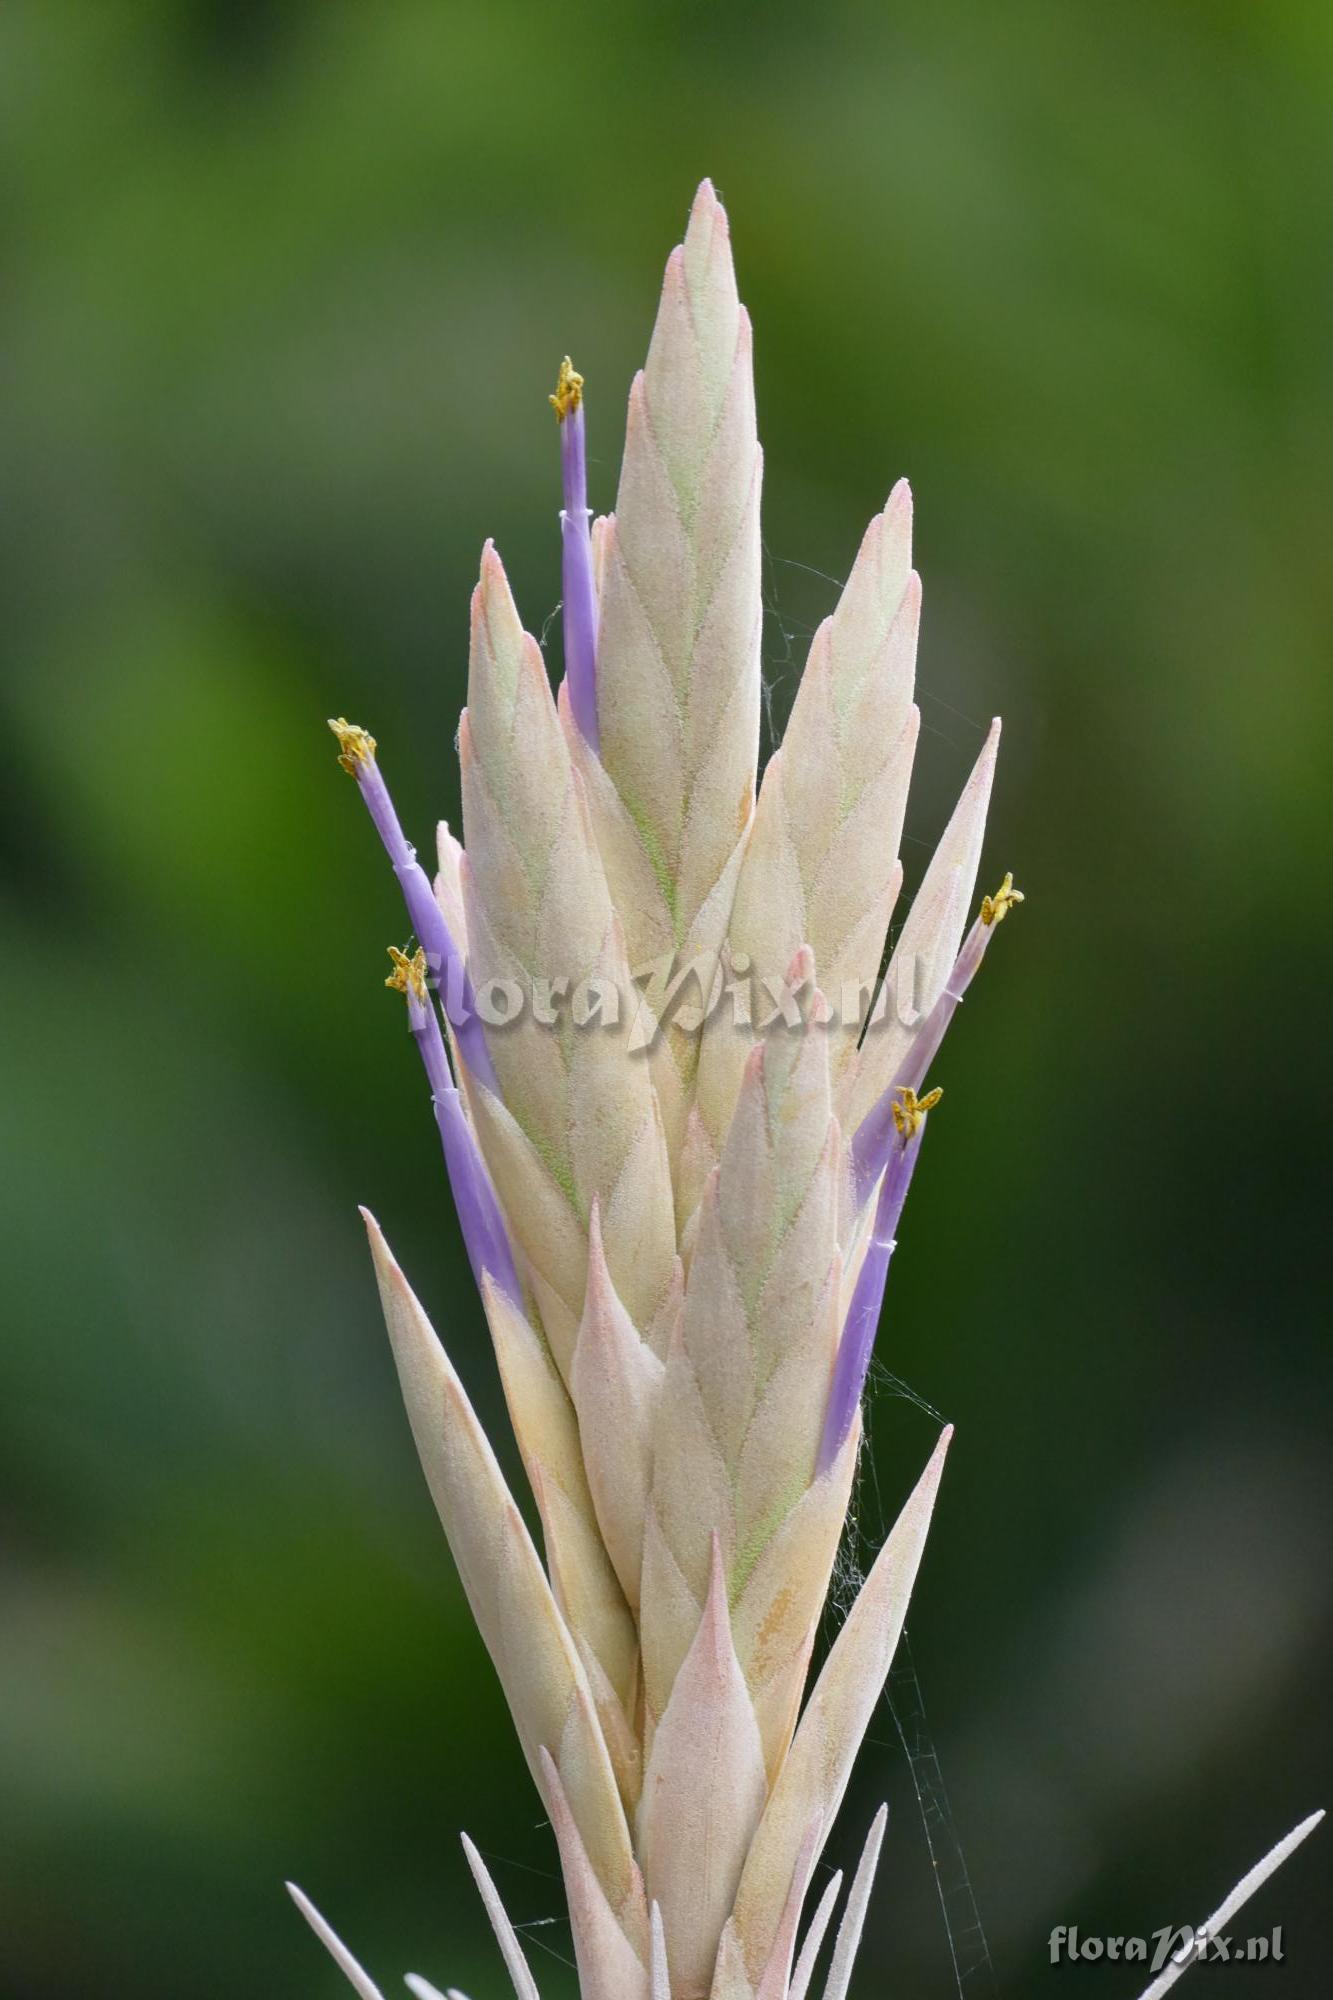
[0,0,1333,2000]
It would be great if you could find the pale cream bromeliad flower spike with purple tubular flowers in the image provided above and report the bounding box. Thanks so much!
[302,182,1021,2000]
